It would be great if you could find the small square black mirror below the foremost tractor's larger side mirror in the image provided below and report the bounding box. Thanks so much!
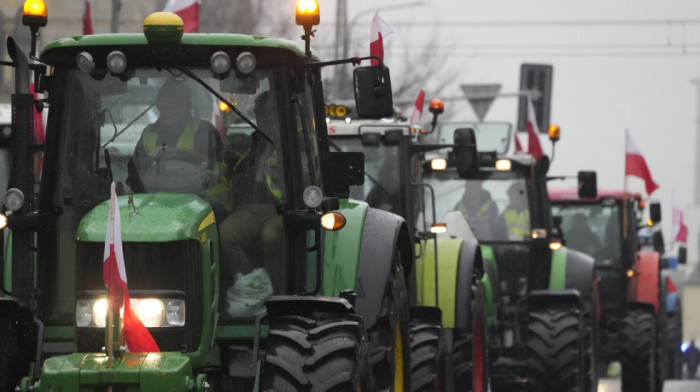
[329,151,365,199]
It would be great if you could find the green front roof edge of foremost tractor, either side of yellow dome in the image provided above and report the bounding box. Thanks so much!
[42,34,304,56]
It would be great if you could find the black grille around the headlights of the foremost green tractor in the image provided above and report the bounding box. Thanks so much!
[76,240,202,352]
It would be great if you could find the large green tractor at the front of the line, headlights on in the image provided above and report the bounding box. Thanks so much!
[0,4,414,391]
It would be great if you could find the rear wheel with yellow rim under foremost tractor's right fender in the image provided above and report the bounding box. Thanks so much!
[367,258,411,392]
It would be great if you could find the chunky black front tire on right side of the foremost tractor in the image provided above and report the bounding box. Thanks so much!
[262,314,371,392]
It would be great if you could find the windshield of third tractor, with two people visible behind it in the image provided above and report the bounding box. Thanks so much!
[426,171,531,242]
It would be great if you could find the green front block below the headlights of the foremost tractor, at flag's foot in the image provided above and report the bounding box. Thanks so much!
[36,352,194,391]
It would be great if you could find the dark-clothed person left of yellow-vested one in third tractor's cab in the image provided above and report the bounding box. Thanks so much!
[453,180,498,239]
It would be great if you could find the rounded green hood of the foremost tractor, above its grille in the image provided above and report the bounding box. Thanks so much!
[77,193,215,242]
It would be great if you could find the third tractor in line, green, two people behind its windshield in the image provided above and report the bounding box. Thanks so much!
[423,122,597,391]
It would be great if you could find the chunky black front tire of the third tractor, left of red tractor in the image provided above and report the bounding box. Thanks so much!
[526,304,586,392]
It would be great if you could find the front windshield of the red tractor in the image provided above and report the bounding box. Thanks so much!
[552,203,621,265]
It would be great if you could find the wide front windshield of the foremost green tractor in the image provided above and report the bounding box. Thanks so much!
[51,68,280,204]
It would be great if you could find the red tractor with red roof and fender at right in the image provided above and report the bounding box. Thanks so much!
[549,189,667,391]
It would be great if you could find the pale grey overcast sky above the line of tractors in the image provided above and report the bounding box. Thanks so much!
[320,0,700,248]
